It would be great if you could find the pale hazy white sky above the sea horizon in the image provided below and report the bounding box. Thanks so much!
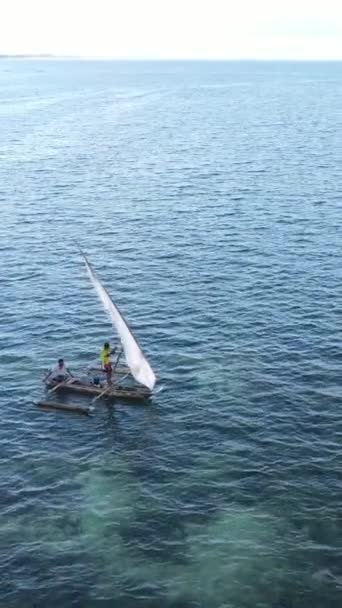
[0,0,342,59]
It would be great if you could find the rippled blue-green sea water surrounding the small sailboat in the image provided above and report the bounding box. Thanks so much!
[0,60,342,608]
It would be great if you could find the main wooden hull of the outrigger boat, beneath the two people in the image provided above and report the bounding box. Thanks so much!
[46,380,152,401]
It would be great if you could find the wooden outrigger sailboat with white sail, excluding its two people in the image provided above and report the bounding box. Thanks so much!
[38,250,156,413]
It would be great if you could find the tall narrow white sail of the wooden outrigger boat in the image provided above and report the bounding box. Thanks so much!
[82,253,156,390]
